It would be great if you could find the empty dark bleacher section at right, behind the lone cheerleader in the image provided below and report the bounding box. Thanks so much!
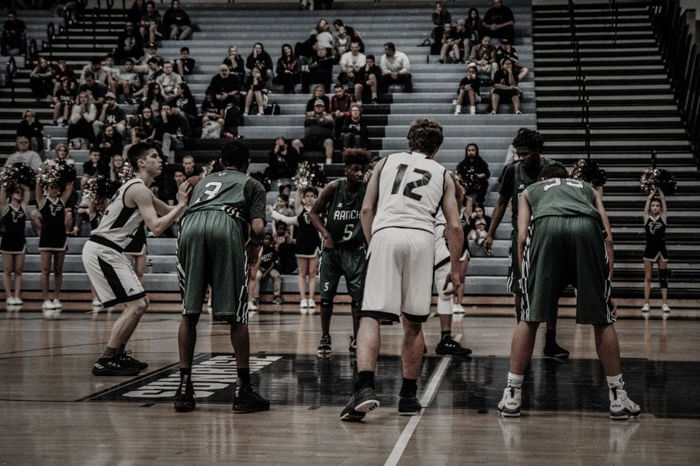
[533,2,700,298]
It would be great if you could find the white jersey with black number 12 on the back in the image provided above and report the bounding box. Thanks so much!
[372,152,446,235]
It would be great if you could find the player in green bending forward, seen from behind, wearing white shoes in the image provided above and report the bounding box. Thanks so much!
[498,165,641,419]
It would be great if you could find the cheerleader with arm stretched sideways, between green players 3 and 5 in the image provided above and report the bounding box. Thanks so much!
[272,186,321,314]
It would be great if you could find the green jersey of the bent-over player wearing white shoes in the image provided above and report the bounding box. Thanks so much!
[527,178,600,221]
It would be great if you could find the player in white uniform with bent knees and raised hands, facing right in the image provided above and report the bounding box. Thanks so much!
[83,143,191,376]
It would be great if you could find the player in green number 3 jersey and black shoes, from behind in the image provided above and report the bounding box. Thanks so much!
[175,141,270,413]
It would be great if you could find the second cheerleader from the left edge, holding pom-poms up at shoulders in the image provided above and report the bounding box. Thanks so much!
[36,180,73,317]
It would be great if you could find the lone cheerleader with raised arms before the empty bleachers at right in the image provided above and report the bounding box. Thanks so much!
[642,188,671,313]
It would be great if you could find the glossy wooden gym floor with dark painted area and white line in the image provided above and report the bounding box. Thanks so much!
[0,307,700,465]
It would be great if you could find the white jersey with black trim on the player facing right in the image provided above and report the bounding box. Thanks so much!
[92,178,144,248]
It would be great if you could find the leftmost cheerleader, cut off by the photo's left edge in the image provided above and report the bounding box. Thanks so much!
[0,185,29,310]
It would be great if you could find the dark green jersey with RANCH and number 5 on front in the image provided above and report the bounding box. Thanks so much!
[326,178,367,246]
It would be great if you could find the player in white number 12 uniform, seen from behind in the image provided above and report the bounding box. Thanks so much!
[340,119,464,421]
